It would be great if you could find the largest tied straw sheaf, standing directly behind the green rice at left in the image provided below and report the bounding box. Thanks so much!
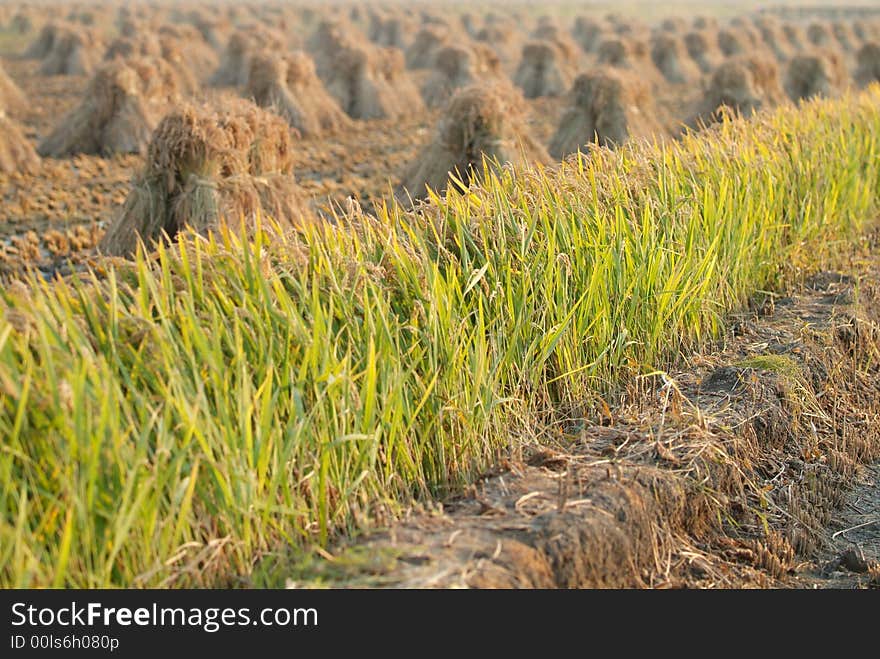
[100,101,310,256]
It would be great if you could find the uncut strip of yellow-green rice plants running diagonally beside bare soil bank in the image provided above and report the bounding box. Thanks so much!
[0,89,880,587]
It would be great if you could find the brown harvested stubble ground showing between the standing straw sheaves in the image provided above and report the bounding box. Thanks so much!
[6,3,858,276]
